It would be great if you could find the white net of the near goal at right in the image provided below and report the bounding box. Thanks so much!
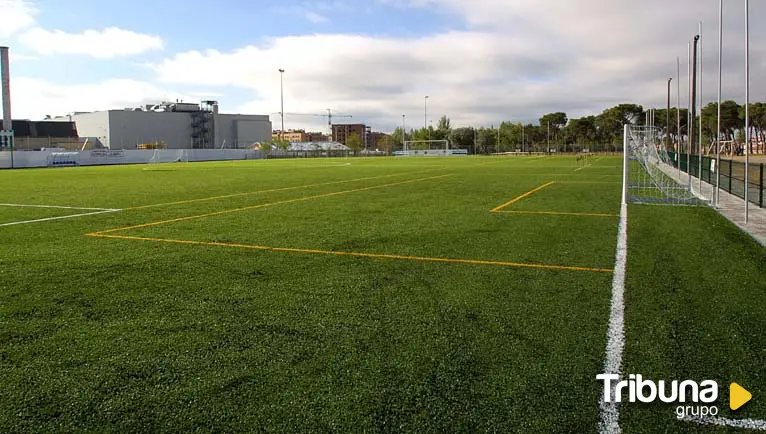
[623,125,707,205]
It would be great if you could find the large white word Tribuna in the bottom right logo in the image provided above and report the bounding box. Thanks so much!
[596,374,718,403]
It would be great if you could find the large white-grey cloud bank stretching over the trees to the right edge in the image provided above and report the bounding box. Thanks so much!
[148,0,766,132]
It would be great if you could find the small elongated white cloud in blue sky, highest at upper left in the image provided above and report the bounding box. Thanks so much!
[19,27,163,59]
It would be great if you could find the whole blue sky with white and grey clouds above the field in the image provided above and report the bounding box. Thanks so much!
[0,0,766,131]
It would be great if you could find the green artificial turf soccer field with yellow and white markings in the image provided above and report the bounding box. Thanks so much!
[0,156,766,433]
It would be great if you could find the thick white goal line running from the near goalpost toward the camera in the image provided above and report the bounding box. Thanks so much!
[599,203,628,434]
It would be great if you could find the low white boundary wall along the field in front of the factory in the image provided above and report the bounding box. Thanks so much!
[0,149,264,169]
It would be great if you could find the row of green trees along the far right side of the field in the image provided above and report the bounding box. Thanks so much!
[377,101,766,154]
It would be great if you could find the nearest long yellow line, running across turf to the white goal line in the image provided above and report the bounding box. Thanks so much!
[88,233,613,273]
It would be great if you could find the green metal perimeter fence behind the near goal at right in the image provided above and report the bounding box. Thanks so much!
[668,152,766,208]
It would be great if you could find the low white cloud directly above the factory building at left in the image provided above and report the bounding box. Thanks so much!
[11,77,192,119]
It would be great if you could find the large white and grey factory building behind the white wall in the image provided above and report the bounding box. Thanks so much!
[55,101,272,149]
